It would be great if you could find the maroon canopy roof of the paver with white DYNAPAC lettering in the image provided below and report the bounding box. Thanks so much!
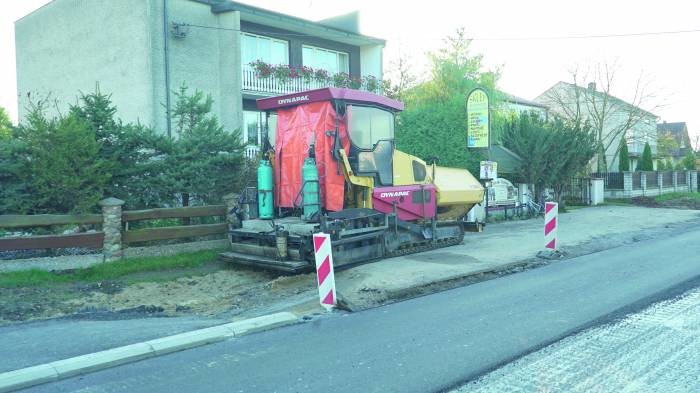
[256,87,404,112]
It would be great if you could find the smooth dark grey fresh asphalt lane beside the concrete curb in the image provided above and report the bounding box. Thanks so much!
[24,224,700,393]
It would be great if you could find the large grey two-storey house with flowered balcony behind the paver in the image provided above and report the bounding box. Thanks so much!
[15,0,385,155]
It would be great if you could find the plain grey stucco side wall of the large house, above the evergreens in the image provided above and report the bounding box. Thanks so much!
[15,0,154,124]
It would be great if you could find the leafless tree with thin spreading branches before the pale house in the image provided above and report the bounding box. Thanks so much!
[544,63,661,172]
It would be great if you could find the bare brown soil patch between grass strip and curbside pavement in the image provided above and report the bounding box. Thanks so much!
[0,261,315,324]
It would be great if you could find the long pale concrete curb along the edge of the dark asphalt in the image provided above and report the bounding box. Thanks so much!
[0,312,299,393]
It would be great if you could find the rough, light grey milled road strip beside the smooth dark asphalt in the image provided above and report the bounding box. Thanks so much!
[460,289,700,393]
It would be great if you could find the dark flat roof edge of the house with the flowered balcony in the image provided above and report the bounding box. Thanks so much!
[205,0,386,46]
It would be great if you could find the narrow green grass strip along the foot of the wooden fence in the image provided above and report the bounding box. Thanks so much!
[0,250,220,288]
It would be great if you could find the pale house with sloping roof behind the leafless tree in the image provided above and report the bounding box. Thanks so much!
[534,82,657,172]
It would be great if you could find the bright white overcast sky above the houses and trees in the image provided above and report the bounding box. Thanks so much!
[0,0,700,145]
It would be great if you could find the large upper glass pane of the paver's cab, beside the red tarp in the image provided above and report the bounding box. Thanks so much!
[348,105,394,150]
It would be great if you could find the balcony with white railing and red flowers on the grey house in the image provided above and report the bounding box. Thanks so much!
[241,65,382,96]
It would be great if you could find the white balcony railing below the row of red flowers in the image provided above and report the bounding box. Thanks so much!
[241,66,381,95]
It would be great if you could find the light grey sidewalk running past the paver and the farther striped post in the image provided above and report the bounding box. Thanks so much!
[336,206,700,310]
